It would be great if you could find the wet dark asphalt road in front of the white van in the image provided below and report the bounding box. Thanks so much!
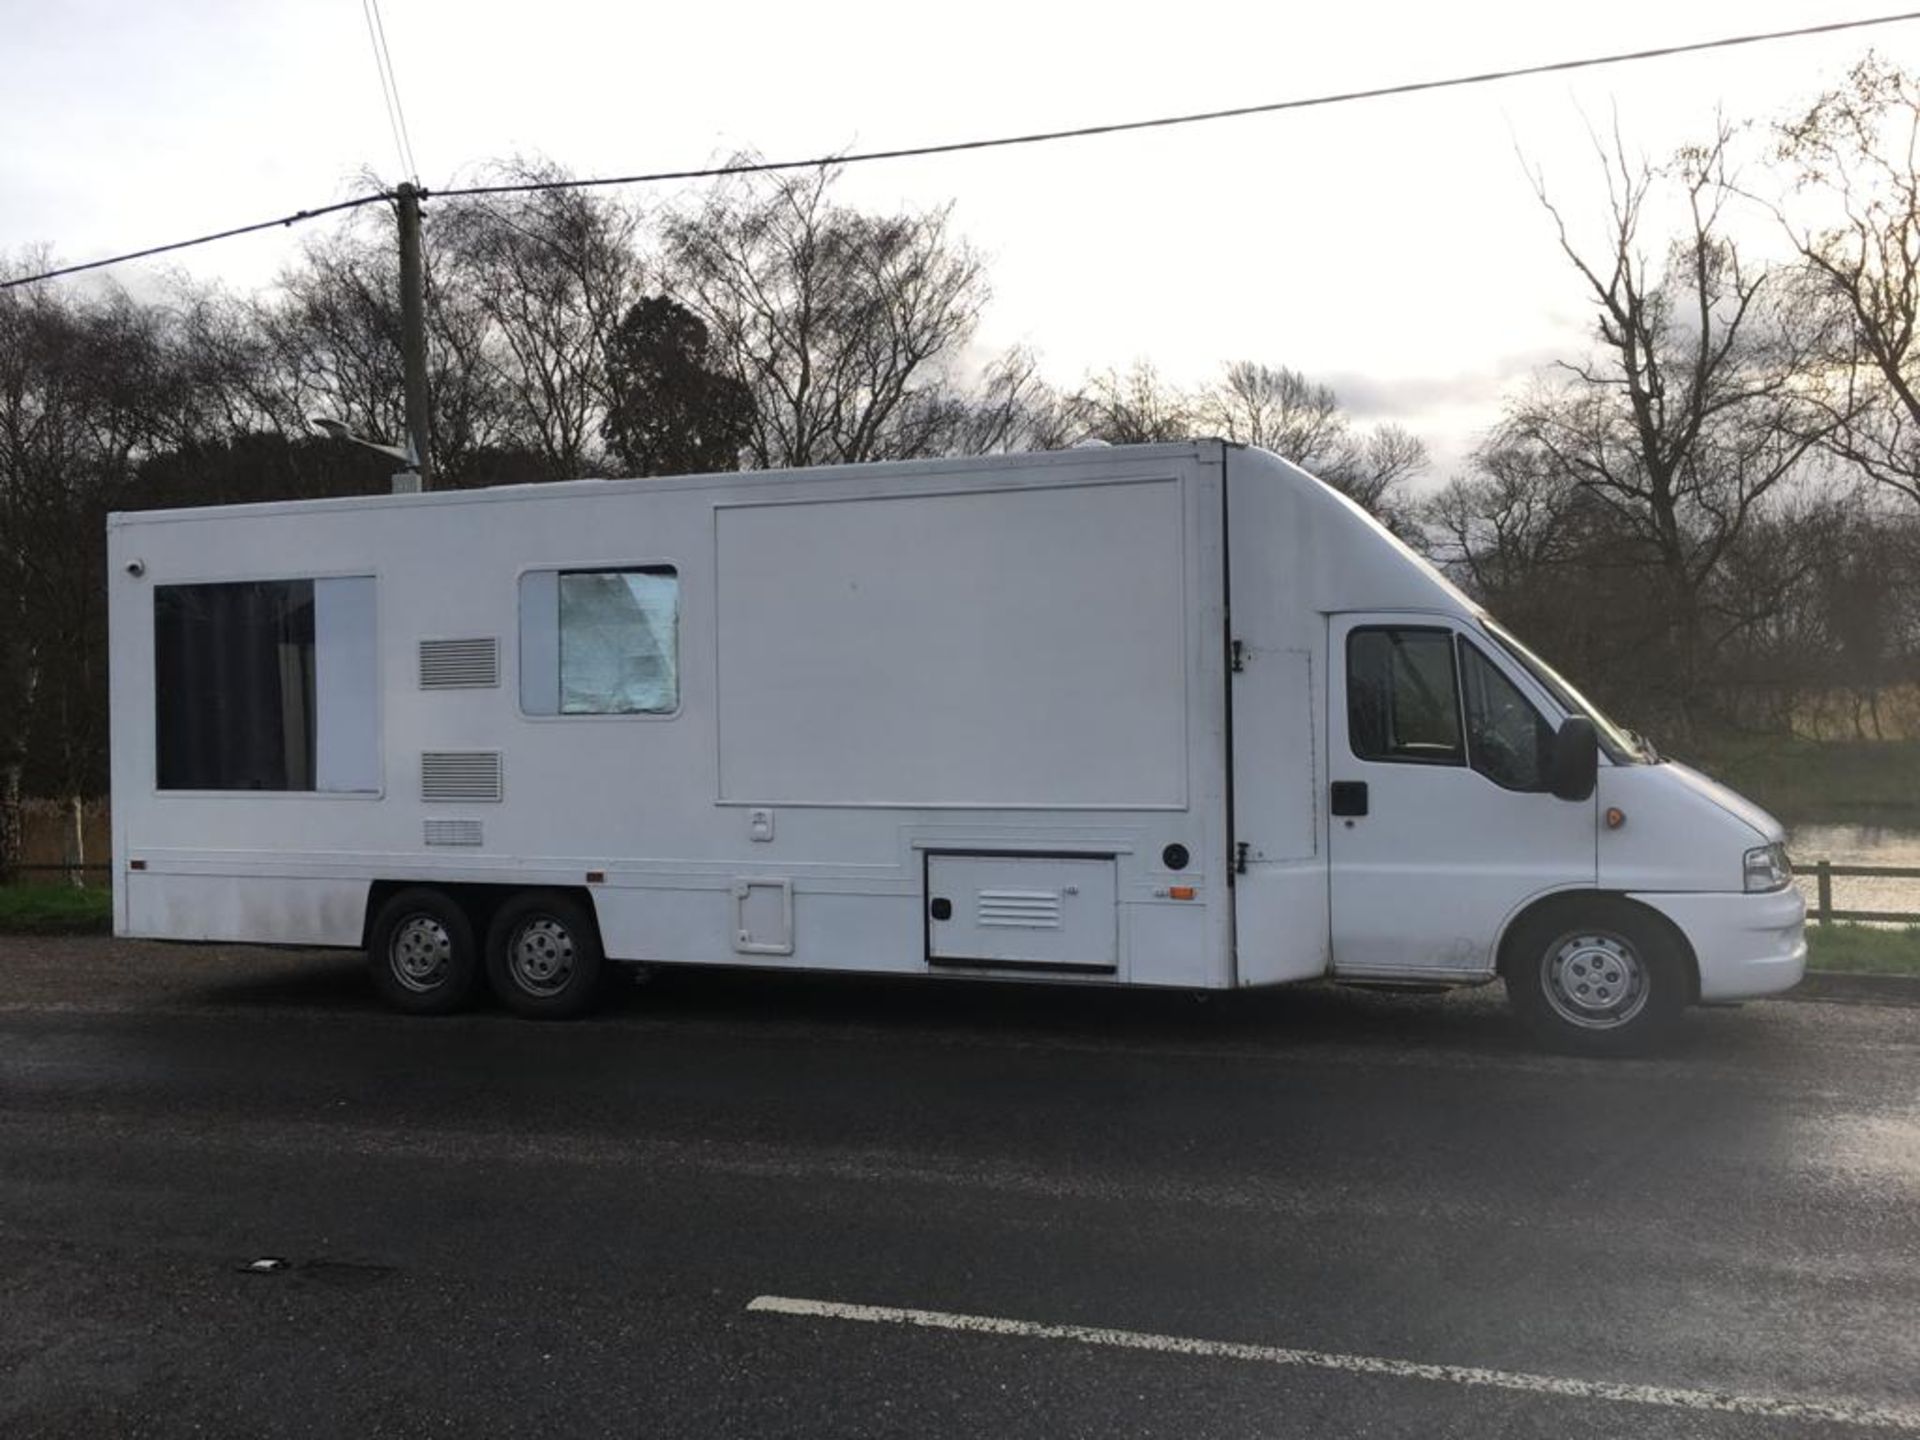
[0,939,1920,1440]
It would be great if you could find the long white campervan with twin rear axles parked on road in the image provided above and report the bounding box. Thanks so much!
[109,442,1805,1048]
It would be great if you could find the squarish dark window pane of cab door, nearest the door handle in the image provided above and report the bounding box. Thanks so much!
[1346,626,1467,764]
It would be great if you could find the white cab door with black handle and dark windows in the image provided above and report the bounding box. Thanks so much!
[1327,614,1597,979]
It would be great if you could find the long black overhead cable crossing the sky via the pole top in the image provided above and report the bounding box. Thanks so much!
[11,10,1920,290]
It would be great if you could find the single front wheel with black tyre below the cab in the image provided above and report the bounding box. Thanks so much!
[1501,900,1692,1054]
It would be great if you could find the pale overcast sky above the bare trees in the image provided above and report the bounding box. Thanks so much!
[0,0,1920,480]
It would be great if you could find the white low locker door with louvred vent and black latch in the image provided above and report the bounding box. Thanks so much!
[927,852,1119,973]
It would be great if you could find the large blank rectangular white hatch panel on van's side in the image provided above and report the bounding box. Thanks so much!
[716,478,1187,808]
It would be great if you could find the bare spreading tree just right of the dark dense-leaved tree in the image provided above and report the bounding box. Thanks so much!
[664,167,987,467]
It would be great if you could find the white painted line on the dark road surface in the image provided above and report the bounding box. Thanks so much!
[747,1294,1920,1432]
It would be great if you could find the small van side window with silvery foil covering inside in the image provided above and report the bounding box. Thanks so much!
[520,564,680,714]
